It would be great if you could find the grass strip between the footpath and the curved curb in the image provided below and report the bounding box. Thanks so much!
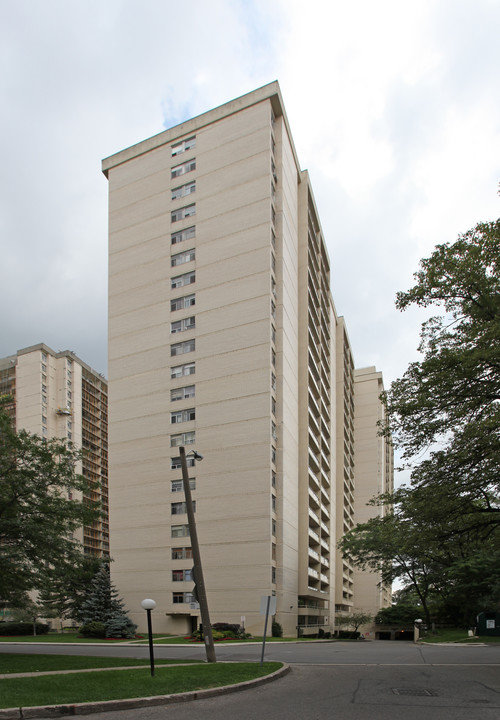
[0,661,282,708]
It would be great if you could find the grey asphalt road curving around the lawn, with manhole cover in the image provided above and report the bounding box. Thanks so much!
[0,641,500,720]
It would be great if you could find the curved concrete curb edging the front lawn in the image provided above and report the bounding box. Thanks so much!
[0,663,290,720]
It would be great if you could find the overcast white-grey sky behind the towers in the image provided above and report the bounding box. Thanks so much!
[0,0,500,385]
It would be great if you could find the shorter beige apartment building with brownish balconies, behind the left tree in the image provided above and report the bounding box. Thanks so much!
[0,343,109,557]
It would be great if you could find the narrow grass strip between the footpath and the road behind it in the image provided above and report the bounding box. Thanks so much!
[0,653,196,675]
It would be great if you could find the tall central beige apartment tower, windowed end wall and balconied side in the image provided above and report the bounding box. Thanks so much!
[103,83,392,635]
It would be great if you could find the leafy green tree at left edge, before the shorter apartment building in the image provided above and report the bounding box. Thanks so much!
[0,402,99,606]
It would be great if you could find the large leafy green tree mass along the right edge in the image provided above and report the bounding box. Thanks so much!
[340,214,500,624]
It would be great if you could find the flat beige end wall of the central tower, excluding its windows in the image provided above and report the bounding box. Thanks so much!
[109,91,288,631]
